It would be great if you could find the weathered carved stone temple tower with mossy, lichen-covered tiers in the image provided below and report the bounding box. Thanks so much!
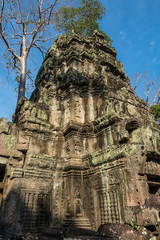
[0,32,160,236]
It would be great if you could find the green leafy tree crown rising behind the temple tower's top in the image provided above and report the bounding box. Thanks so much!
[55,0,112,43]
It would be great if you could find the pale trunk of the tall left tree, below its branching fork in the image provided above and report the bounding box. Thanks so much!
[17,57,27,103]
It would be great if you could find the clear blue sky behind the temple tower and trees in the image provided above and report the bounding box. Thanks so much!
[0,0,160,120]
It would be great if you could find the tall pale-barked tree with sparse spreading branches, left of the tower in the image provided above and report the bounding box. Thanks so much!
[0,0,67,101]
